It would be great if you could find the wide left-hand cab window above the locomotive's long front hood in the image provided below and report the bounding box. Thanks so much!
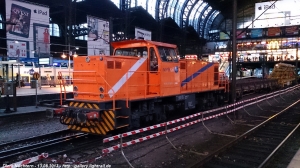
[114,47,148,57]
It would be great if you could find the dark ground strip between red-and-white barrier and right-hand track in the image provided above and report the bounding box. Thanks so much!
[94,91,299,168]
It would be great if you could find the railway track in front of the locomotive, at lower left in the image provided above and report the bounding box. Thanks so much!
[0,130,90,165]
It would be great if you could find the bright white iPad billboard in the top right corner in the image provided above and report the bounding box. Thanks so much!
[253,0,300,28]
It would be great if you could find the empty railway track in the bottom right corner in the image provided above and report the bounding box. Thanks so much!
[191,100,300,168]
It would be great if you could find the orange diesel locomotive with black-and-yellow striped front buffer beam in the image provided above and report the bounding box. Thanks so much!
[60,40,228,135]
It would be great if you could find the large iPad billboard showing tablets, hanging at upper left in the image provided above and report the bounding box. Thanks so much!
[6,0,50,58]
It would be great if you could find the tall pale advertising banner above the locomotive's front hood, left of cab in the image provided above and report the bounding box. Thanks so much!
[87,16,110,55]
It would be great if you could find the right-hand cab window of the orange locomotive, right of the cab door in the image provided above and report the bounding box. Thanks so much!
[157,46,178,62]
